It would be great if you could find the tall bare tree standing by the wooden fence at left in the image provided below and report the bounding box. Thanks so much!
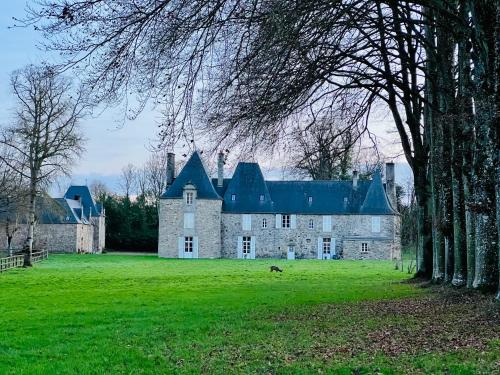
[0,65,87,266]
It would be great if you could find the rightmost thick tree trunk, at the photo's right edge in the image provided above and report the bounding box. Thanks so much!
[471,0,498,290]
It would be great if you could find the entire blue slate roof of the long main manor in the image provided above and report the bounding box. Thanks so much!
[161,152,397,215]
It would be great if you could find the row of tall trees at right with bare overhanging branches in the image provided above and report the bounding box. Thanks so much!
[25,0,500,296]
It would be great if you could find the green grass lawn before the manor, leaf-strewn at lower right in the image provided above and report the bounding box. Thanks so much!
[0,255,500,374]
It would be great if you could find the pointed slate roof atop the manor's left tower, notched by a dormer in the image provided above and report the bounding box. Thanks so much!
[160,151,221,199]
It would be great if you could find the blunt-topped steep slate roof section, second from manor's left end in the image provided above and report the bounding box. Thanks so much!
[222,163,274,212]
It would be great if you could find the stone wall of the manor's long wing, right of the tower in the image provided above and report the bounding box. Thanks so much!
[222,213,400,259]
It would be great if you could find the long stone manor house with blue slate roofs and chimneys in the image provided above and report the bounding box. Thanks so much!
[158,152,401,259]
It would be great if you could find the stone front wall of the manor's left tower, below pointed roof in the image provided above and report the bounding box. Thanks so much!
[158,199,222,258]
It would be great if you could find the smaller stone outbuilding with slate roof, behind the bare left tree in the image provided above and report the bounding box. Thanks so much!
[0,186,106,253]
